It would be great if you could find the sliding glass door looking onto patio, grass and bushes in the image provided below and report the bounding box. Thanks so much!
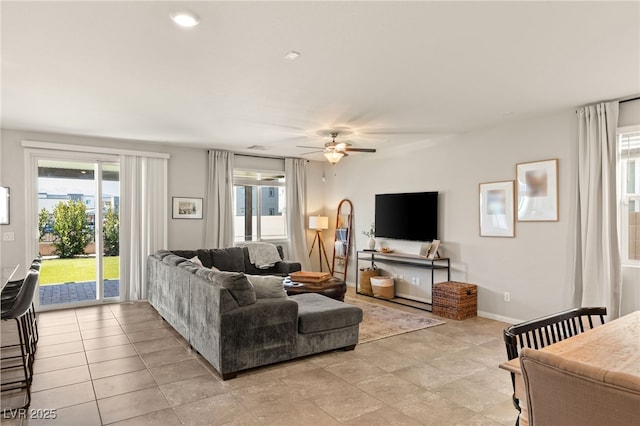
[33,154,120,309]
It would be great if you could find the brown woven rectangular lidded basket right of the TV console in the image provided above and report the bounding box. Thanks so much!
[433,281,478,320]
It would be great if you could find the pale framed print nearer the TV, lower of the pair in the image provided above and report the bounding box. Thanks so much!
[480,180,515,237]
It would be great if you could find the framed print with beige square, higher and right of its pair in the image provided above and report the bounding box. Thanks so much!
[516,159,558,222]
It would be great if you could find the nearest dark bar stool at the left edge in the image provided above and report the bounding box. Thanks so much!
[1,269,39,414]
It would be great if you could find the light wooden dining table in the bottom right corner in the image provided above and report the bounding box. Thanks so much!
[500,311,640,426]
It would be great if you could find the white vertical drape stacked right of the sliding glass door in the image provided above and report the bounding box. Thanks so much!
[120,155,169,301]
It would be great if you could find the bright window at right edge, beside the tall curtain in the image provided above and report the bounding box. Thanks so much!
[618,127,640,265]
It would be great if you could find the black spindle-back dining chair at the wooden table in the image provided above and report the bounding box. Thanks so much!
[503,307,607,426]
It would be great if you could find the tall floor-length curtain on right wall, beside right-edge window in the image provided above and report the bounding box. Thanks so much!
[574,102,622,318]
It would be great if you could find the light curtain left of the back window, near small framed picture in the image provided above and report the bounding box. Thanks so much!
[204,150,233,248]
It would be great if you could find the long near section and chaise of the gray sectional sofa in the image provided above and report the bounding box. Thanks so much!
[147,248,362,380]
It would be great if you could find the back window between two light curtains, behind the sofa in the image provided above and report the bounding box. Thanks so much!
[233,169,287,242]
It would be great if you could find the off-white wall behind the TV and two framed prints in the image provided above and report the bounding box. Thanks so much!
[326,106,640,320]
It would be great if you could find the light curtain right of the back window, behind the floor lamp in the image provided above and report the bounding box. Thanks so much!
[284,158,311,271]
